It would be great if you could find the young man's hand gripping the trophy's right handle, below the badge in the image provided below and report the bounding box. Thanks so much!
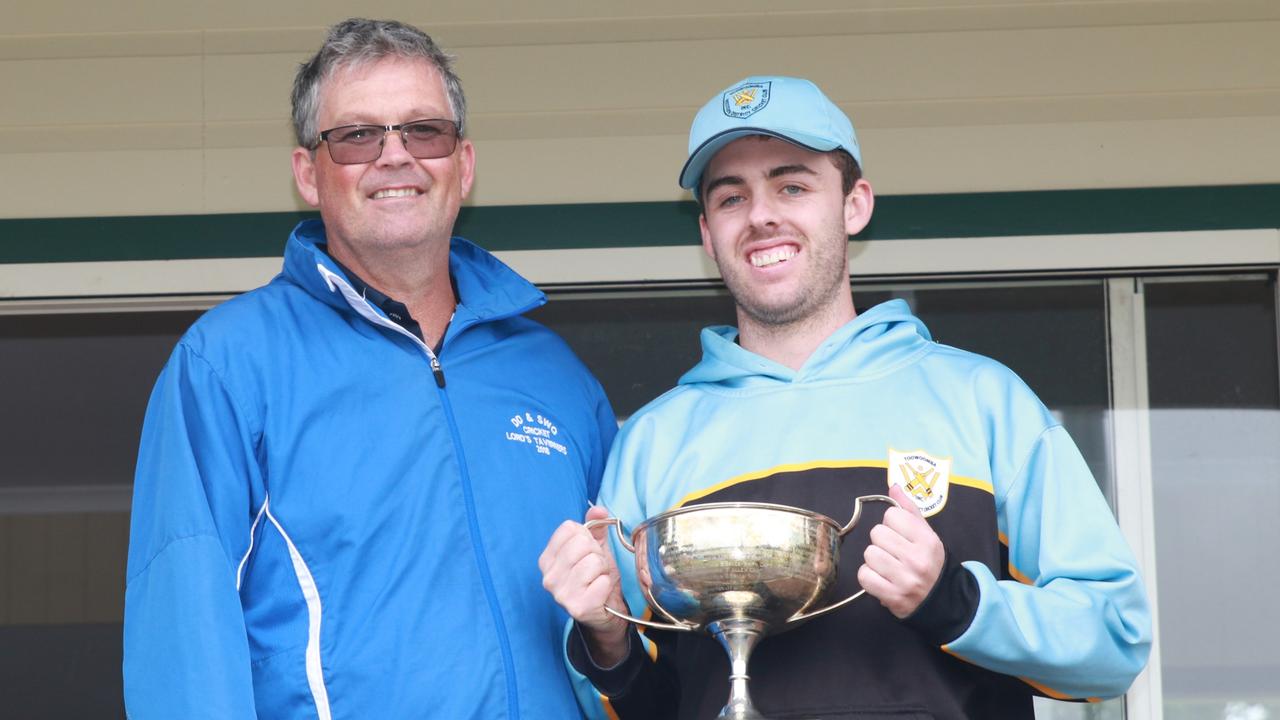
[858,486,946,618]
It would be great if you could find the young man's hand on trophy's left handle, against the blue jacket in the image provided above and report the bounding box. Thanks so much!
[538,506,630,667]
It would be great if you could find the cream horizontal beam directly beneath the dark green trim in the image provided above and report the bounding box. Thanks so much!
[0,228,1280,298]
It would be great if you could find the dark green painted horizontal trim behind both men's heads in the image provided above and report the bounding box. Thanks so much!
[0,183,1280,263]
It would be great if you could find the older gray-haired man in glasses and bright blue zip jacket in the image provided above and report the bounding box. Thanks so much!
[124,19,617,720]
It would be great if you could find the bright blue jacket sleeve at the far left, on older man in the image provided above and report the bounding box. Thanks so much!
[124,345,262,720]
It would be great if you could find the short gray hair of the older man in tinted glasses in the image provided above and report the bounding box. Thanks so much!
[292,18,467,150]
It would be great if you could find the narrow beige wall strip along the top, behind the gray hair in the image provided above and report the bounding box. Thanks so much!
[0,0,1280,61]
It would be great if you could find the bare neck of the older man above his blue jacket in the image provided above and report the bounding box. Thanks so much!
[329,243,457,347]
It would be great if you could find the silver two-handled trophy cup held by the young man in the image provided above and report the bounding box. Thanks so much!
[586,495,897,720]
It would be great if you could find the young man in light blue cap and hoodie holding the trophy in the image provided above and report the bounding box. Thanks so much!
[539,77,1151,720]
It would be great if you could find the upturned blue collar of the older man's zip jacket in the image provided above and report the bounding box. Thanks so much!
[283,215,547,323]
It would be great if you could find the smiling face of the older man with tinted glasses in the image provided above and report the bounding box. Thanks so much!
[293,58,475,273]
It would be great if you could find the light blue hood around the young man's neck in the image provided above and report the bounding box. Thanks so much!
[680,300,933,388]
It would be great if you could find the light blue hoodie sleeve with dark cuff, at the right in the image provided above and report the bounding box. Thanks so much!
[909,425,1152,700]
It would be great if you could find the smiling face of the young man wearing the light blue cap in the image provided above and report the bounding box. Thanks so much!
[699,136,872,329]
